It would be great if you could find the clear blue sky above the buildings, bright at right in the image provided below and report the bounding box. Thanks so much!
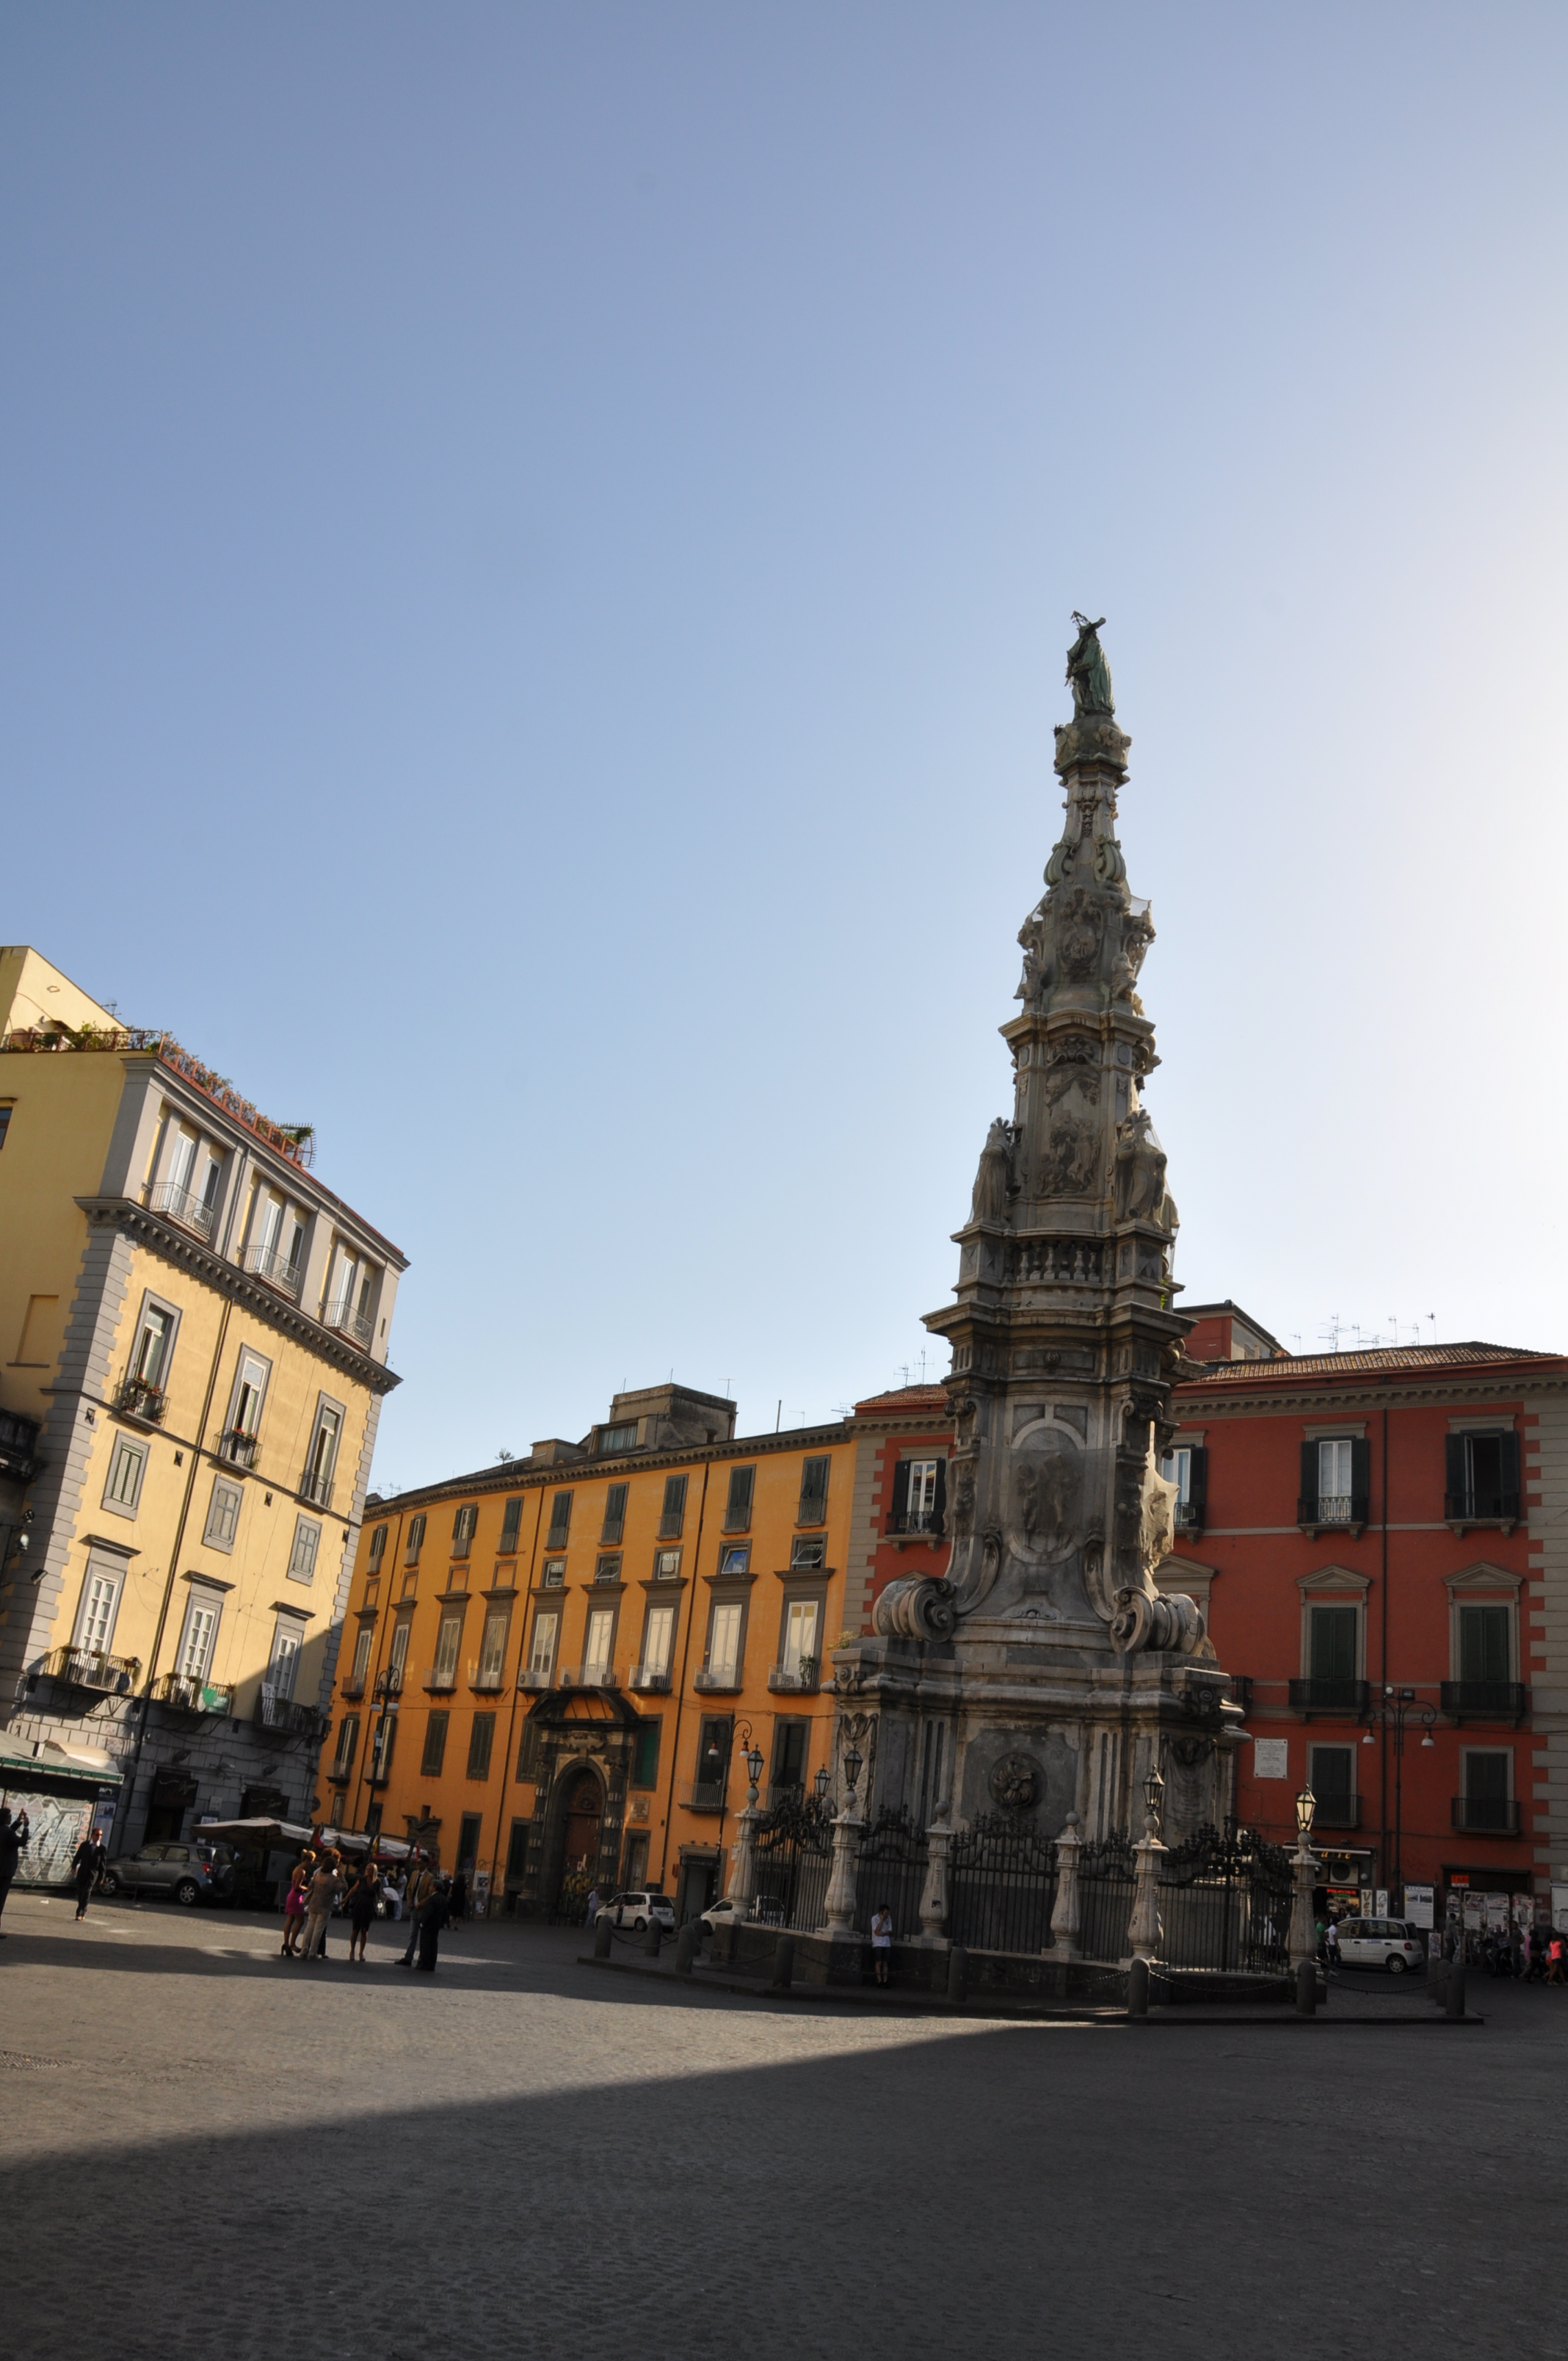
[0,0,1568,1483]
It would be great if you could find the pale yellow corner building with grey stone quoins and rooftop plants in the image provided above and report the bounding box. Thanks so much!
[0,947,406,1877]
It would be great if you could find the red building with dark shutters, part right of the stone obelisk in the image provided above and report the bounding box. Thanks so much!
[1162,1303,1568,1920]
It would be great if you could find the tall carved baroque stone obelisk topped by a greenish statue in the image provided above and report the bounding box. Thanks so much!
[836,614,1240,1837]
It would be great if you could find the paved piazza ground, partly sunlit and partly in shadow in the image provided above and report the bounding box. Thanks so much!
[0,1893,1568,2361]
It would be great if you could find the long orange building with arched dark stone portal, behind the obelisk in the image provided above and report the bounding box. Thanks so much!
[321,1386,855,1917]
